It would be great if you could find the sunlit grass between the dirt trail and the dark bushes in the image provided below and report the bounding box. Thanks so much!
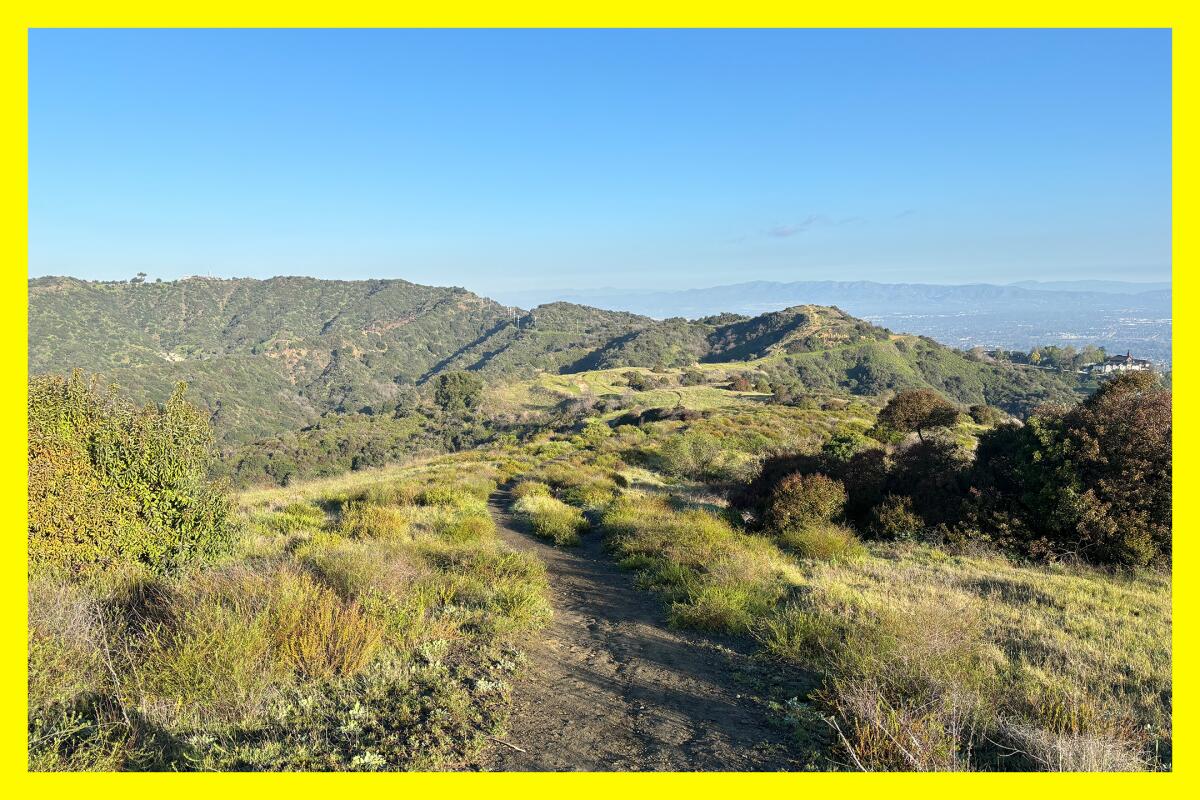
[604,482,1171,770]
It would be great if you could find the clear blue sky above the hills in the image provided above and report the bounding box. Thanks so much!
[29,30,1171,294]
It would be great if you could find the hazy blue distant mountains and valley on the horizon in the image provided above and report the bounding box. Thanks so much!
[487,281,1171,365]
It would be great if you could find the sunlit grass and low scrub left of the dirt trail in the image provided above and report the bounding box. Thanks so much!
[29,453,550,770]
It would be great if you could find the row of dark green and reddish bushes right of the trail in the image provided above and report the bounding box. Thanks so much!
[733,373,1171,566]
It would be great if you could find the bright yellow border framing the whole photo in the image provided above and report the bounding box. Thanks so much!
[7,6,1200,800]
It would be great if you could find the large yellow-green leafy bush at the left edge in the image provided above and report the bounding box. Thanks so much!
[29,371,232,571]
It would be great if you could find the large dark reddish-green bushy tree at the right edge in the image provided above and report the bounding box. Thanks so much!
[973,372,1171,566]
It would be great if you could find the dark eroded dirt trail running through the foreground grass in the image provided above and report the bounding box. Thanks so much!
[481,489,797,771]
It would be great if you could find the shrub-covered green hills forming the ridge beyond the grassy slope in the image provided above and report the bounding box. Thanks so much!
[29,277,1084,441]
